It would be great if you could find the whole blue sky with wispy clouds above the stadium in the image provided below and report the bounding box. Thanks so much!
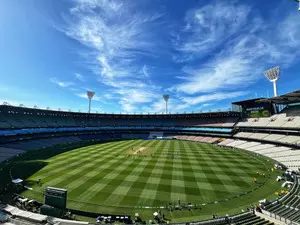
[0,0,300,113]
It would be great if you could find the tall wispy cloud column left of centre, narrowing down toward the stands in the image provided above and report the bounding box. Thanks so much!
[61,0,162,111]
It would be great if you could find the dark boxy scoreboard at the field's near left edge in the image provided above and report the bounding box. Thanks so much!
[44,187,68,209]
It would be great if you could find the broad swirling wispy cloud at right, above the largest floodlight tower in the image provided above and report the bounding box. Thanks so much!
[170,2,300,94]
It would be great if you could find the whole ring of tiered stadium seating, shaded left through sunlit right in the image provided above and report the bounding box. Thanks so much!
[0,90,300,224]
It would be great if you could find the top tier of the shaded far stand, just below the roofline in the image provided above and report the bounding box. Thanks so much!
[0,105,239,129]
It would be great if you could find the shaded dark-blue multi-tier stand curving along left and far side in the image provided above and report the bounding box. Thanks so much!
[0,105,239,161]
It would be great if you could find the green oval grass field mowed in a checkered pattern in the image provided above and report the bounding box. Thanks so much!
[22,140,279,221]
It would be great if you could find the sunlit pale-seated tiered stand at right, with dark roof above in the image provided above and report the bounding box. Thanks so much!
[230,91,300,170]
